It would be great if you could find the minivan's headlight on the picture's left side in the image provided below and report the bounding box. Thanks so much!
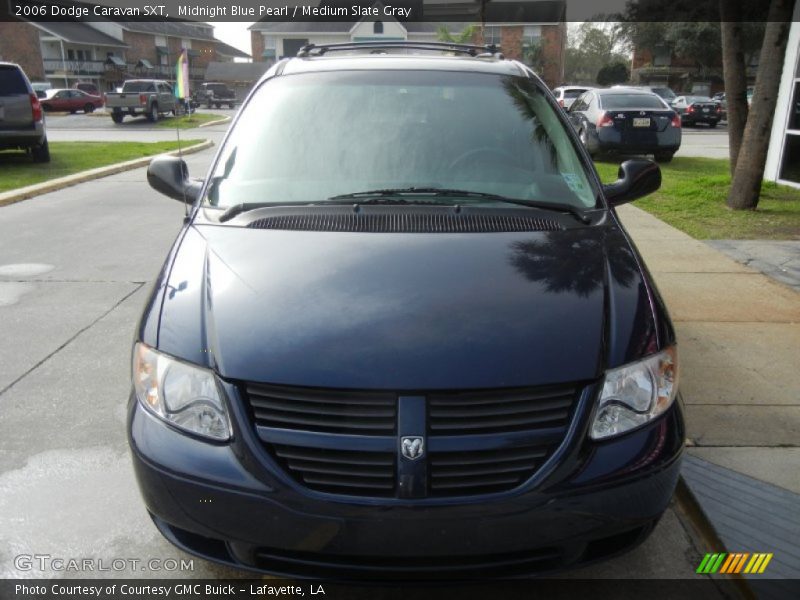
[133,344,231,441]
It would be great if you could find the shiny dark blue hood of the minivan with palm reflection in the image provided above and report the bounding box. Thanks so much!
[158,225,652,390]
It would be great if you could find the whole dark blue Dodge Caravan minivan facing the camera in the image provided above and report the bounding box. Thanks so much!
[128,42,684,581]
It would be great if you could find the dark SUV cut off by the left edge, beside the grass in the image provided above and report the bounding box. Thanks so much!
[0,62,50,163]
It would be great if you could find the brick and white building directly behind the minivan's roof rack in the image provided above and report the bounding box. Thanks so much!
[250,0,567,87]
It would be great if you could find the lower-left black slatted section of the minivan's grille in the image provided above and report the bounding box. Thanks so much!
[273,445,396,496]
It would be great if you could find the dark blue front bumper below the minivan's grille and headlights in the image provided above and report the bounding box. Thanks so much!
[128,384,684,579]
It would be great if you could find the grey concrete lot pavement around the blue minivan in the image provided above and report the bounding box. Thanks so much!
[0,115,727,597]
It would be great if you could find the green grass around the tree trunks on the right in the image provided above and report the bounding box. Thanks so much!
[595,157,800,240]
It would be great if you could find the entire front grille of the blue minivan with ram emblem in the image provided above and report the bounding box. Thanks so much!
[240,383,580,498]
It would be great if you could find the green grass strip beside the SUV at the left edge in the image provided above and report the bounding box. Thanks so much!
[0,140,202,192]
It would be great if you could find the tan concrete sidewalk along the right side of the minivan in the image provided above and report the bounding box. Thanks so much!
[619,205,800,578]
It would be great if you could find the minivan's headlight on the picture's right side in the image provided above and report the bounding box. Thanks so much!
[589,346,678,440]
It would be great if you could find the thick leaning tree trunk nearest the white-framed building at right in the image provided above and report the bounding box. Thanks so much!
[728,0,795,210]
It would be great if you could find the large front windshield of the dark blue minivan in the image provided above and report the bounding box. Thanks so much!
[204,70,597,209]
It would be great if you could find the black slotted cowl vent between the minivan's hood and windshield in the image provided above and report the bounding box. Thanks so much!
[247,211,562,233]
